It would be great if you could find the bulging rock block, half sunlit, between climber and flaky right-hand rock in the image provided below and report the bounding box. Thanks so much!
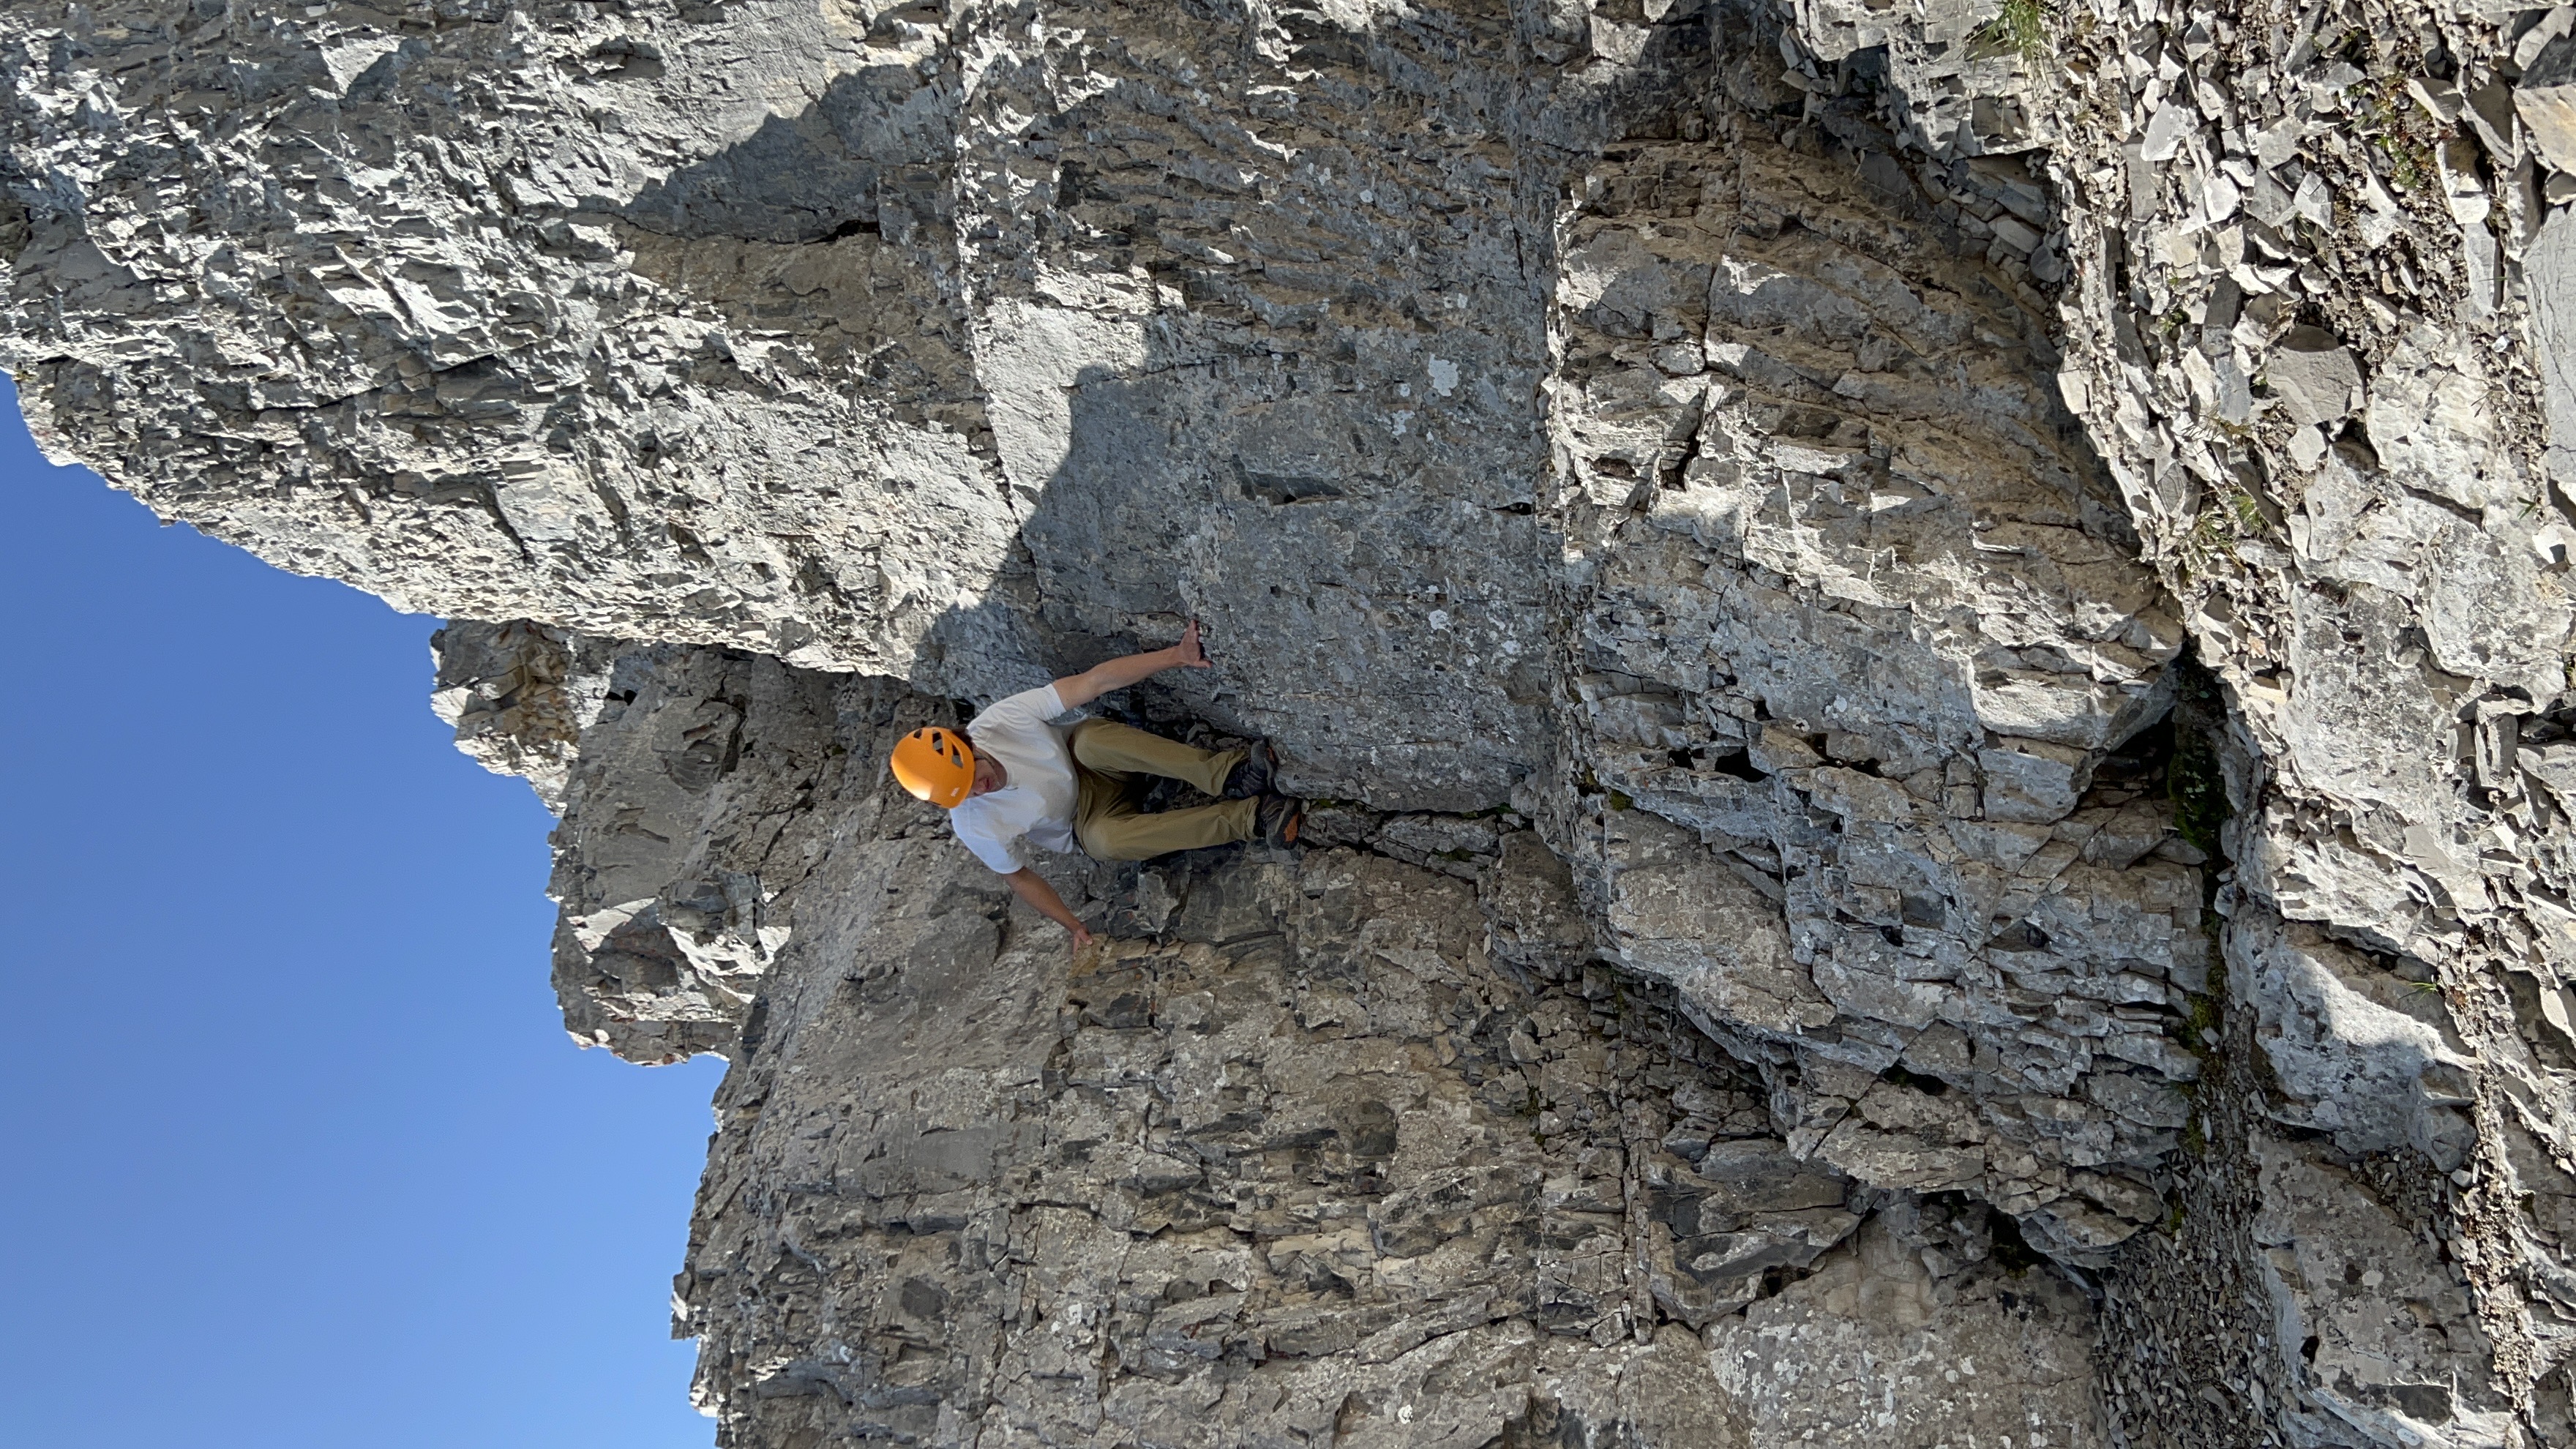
[1522,64,2208,1258]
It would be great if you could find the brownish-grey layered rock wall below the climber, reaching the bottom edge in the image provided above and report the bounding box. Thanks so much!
[528,634,2102,1449]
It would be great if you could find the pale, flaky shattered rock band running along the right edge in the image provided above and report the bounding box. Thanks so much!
[1761,5,2576,1444]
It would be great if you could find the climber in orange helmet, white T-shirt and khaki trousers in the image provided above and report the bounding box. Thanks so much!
[891,619,1303,949]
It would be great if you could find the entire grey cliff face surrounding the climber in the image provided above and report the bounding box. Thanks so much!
[15,0,2576,1449]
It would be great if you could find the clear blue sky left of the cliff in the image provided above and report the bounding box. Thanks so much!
[0,392,724,1449]
